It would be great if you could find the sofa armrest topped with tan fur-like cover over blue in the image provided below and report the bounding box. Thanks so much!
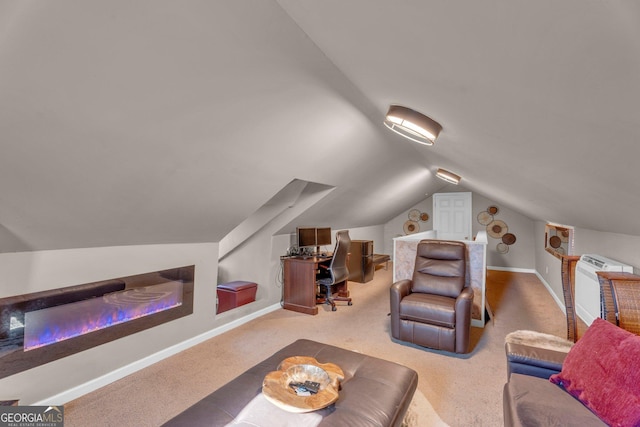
[505,331,573,379]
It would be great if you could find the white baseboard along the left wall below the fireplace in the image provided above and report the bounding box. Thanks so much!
[32,303,282,406]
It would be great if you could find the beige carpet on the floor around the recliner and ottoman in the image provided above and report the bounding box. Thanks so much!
[65,266,566,427]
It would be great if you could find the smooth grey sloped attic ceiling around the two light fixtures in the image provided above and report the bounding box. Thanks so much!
[0,0,640,252]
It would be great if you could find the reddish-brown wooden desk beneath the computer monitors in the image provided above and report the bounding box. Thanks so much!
[283,257,349,314]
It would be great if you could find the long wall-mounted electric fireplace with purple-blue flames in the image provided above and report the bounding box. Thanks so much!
[0,266,195,378]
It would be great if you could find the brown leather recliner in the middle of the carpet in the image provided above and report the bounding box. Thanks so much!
[391,240,473,353]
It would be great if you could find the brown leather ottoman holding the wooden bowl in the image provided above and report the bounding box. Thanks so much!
[164,339,418,427]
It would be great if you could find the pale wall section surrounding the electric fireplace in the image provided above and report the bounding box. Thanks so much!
[0,243,224,405]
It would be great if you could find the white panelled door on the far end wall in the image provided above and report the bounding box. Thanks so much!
[433,193,472,240]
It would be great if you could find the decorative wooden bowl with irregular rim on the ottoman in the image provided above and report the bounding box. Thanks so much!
[262,356,344,413]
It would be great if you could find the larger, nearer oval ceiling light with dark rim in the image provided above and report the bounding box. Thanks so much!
[384,105,442,145]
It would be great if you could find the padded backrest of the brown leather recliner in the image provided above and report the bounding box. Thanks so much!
[411,240,467,298]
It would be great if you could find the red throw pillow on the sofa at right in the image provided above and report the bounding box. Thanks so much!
[549,318,640,427]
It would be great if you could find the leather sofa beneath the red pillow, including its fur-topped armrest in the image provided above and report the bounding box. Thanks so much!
[503,331,606,427]
